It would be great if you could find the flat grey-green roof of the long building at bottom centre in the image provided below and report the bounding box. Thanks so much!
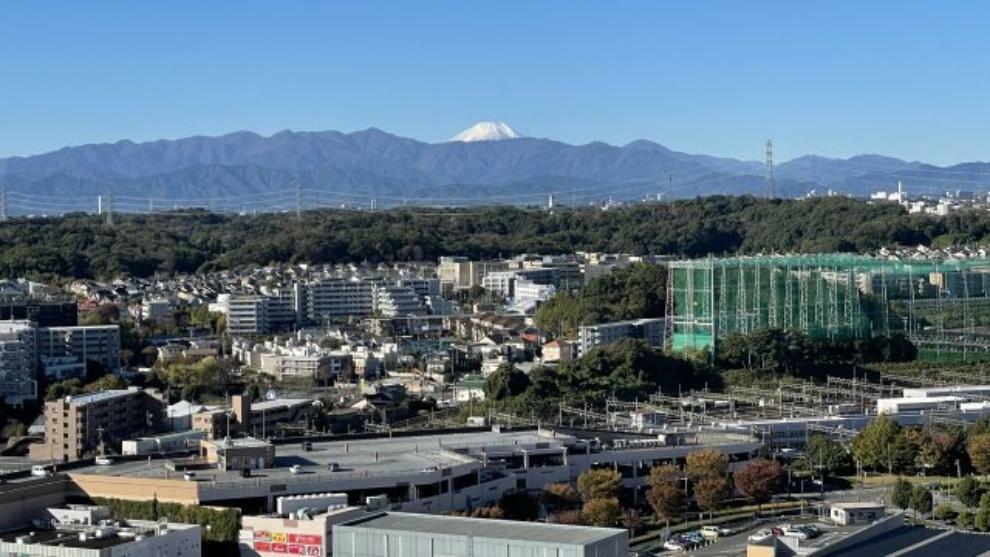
[343,513,626,545]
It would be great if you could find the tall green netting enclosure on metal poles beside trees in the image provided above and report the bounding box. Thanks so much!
[666,253,990,361]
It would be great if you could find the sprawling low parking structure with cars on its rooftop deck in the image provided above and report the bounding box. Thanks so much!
[62,428,760,513]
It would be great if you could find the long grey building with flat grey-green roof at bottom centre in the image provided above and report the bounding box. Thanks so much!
[333,513,629,557]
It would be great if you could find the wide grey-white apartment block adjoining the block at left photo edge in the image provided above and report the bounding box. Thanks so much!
[35,325,120,373]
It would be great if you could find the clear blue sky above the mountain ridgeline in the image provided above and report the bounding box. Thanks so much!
[0,0,990,164]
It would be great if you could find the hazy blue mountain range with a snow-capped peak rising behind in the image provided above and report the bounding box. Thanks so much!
[0,123,990,213]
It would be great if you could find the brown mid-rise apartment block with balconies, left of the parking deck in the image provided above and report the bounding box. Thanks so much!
[30,388,165,461]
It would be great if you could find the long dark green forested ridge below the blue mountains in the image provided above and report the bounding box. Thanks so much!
[0,196,990,278]
